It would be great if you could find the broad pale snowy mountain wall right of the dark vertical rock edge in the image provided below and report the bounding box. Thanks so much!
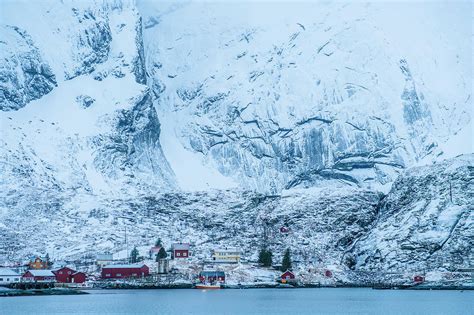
[138,1,473,192]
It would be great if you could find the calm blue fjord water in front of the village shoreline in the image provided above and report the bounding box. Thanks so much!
[0,288,474,315]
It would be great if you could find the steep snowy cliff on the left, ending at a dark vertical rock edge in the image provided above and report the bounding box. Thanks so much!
[0,1,174,198]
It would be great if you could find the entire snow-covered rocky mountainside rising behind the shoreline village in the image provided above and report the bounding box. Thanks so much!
[0,0,474,276]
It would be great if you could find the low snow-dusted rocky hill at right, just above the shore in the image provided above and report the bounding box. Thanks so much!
[353,154,474,270]
